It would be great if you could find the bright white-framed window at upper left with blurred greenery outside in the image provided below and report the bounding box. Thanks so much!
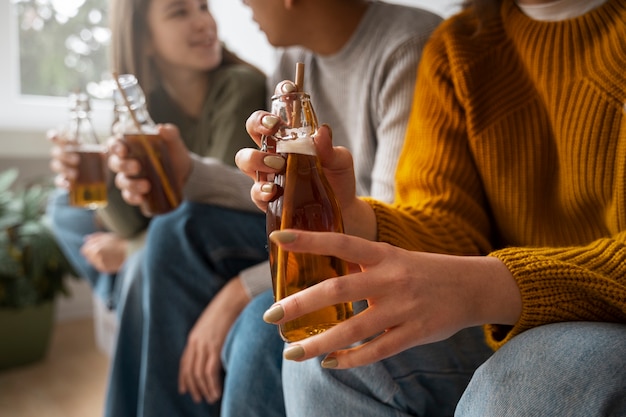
[0,0,112,133]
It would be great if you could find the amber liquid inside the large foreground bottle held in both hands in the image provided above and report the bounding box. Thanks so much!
[267,145,353,342]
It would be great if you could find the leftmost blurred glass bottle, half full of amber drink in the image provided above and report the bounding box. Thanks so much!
[62,92,108,210]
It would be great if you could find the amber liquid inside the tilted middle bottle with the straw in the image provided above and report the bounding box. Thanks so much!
[124,134,182,214]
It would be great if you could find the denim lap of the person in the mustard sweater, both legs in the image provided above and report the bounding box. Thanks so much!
[283,322,626,417]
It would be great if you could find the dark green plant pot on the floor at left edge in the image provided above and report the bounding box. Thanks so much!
[0,301,54,370]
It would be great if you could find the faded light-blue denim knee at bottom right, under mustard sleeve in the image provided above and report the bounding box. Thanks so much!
[456,322,626,417]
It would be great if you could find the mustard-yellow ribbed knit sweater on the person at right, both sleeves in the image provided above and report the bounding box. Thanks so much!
[368,0,626,348]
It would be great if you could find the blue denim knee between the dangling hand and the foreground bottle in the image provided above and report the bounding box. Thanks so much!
[221,291,285,417]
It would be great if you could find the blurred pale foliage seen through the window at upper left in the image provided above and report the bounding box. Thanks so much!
[11,0,111,98]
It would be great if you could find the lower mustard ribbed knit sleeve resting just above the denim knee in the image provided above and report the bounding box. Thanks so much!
[485,232,626,348]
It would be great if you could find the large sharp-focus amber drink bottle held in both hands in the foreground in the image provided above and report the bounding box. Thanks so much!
[267,92,353,342]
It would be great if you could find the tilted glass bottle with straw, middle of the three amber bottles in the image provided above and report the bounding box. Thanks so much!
[113,74,182,215]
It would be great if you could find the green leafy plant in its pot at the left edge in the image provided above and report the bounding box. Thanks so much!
[0,169,75,370]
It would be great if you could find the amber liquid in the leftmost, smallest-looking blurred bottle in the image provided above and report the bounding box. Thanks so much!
[69,147,107,210]
